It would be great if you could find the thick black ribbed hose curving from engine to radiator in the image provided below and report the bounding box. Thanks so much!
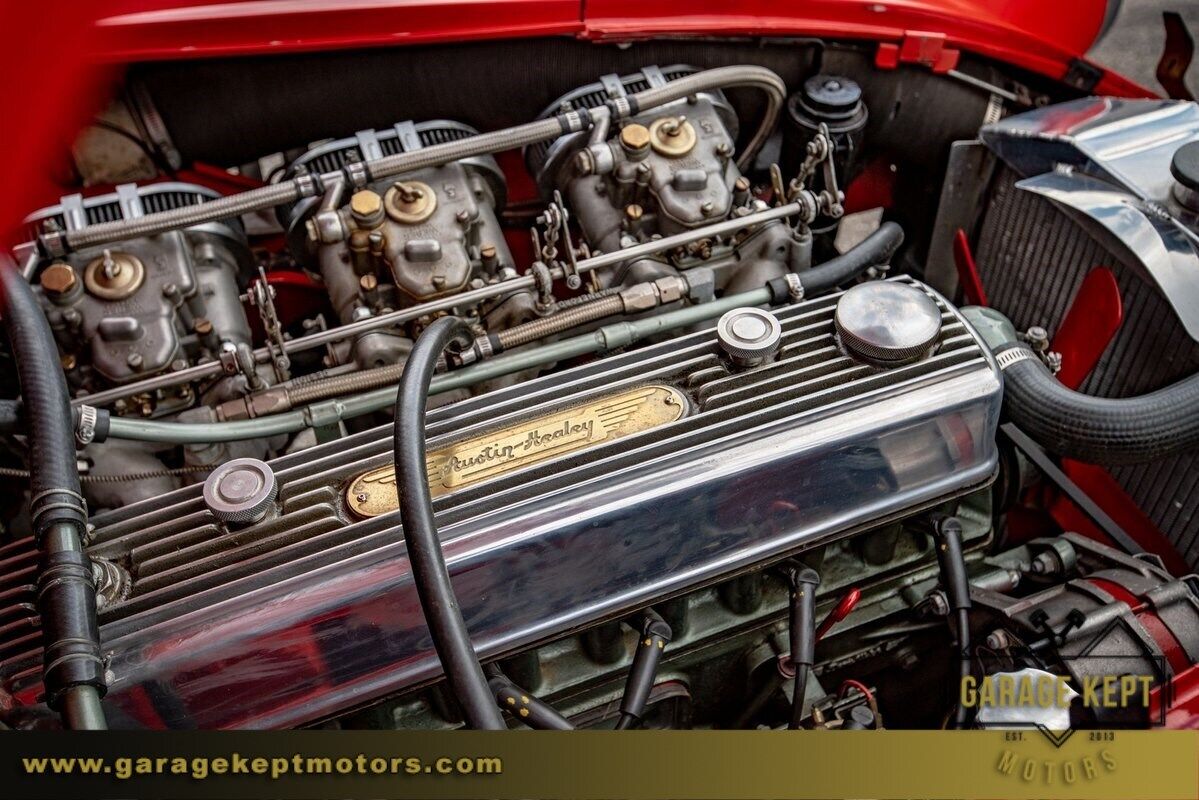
[996,344,1199,465]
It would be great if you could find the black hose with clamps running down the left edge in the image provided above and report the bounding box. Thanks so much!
[0,254,107,729]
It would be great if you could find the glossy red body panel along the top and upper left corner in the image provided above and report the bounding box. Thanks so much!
[0,0,1149,241]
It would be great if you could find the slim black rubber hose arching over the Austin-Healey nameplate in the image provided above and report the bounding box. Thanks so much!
[392,317,507,730]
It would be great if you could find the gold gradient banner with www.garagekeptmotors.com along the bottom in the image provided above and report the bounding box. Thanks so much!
[0,730,1199,800]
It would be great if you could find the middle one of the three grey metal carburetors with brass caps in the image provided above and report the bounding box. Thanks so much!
[281,120,512,366]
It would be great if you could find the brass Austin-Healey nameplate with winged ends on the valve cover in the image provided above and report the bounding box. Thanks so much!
[345,386,687,517]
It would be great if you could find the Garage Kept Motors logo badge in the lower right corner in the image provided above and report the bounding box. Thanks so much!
[958,614,1171,747]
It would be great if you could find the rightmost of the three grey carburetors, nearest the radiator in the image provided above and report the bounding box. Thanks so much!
[525,65,811,291]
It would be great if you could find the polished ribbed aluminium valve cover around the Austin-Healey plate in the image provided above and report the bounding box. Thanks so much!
[0,278,1001,728]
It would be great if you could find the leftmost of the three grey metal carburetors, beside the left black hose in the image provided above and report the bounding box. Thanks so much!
[26,184,251,415]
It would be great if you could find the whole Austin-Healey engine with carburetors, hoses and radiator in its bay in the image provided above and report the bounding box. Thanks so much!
[0,41,1199,729]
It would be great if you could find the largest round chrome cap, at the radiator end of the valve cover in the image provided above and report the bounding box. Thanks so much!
[833,281,941,366]
